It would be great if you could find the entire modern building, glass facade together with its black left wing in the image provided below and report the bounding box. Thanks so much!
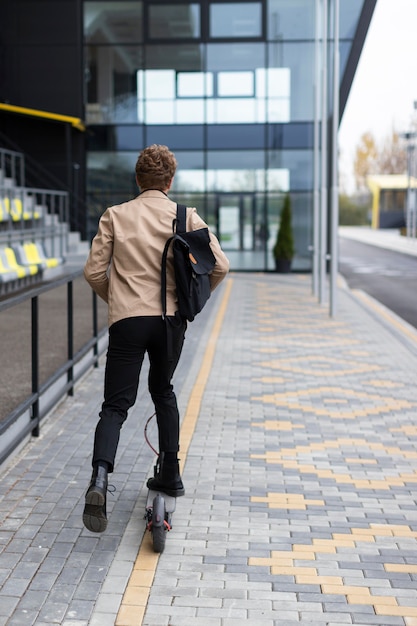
[0,0,377,274]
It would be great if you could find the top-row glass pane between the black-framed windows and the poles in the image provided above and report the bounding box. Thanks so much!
[267,0,314,41]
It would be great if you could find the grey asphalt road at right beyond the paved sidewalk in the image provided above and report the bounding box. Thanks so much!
[339,237,417,328]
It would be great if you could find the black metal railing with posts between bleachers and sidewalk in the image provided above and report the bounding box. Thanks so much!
[0,270,107,464]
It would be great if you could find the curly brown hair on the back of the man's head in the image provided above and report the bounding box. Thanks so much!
[135,144,177,191]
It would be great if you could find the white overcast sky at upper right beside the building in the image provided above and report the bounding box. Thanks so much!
[339,0,417,190]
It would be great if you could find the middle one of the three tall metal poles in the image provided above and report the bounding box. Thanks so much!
[319,0,328,303]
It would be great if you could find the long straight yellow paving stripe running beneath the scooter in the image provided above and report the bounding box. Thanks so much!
[115,279,233,626]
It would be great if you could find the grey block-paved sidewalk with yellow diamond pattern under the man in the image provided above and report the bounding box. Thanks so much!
[0,274,417,626]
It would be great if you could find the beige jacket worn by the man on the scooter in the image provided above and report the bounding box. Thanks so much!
[84,189,229,326]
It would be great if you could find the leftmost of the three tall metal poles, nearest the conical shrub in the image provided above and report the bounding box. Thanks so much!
[312,0,321,296]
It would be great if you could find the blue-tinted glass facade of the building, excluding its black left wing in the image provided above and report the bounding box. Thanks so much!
[84,0,375,271]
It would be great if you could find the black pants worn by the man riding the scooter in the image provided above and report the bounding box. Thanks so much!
[93,316,186,472]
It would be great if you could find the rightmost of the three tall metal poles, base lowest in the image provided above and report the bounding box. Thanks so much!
[330,0,340,317]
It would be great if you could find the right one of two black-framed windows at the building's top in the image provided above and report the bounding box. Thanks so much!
[210,2,262,38]
